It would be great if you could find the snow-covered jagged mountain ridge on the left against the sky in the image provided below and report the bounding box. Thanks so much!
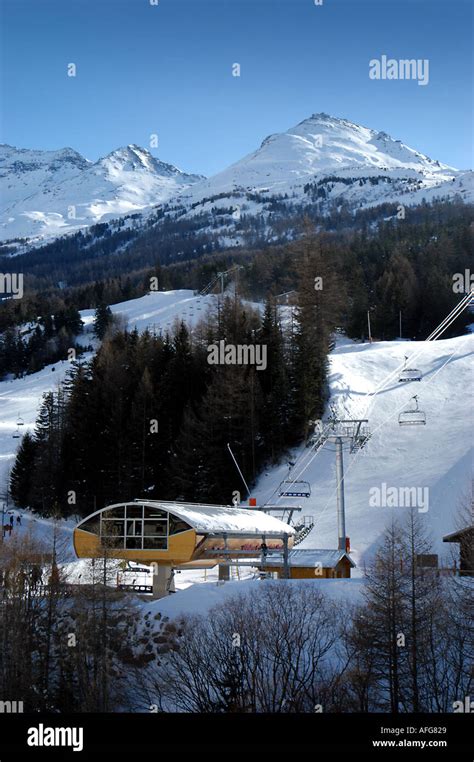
[0,145,202,240]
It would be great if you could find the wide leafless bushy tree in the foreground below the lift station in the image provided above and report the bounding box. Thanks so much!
[142,582,338,712]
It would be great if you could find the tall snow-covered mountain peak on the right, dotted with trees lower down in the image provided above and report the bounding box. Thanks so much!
[172,113,474,235]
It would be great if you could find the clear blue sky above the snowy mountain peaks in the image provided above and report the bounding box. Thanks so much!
[0,0,473,175]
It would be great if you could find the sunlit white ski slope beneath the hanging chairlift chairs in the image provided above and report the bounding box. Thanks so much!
[252,334,474,562]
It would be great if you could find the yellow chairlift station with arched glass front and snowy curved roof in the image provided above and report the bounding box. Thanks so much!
[73,500,296,597]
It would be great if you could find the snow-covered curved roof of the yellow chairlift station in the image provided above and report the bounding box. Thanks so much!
[136,500,295,536]
